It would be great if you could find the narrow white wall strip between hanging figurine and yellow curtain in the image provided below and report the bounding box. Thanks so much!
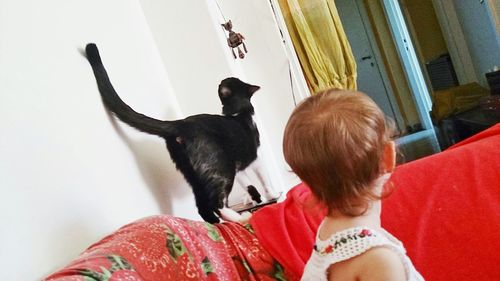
[214,0,302,186]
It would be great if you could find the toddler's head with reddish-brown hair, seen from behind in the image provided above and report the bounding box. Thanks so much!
[283,90,394,215]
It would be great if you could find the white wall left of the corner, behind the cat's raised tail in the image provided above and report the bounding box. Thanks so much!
[0,0,191,280]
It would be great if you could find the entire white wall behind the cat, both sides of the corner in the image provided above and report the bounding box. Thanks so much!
[0,0,296,280]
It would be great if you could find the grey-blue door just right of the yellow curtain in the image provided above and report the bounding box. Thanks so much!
[335,0,404,129]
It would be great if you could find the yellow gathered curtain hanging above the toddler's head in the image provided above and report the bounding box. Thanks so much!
[279,0,356,94]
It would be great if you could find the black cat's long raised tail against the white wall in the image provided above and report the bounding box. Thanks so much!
[85,43,178,137]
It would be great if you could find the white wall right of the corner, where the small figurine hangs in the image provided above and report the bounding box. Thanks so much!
[140,0,297,196]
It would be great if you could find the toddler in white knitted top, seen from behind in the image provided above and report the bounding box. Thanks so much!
[283,90,423,281]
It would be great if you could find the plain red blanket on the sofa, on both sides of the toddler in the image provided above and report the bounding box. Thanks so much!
[250,124,500,281]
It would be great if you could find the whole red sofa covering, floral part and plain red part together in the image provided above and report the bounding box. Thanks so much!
[44,124,500,281]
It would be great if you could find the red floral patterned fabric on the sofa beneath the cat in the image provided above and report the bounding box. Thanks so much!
[45,215,286,281]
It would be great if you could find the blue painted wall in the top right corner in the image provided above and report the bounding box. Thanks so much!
[453,0,500,86]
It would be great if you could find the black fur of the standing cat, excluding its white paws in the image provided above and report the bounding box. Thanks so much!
[85,44,260,223]
